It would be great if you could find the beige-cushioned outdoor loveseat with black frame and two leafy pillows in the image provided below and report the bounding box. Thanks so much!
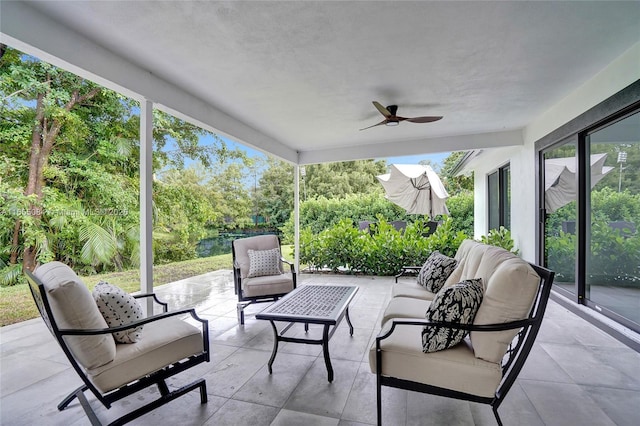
[369,240,554,425]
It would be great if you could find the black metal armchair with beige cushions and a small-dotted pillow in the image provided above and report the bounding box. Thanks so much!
[25,262,209,425]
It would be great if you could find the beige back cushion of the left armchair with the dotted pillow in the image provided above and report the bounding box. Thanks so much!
[34,262,116,368]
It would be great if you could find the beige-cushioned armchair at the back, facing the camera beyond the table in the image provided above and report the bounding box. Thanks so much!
[231,235,296,324]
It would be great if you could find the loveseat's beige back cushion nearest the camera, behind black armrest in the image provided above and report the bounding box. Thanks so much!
[471,260,540,362]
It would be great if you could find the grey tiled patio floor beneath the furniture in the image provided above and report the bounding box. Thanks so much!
[0,271,640,426]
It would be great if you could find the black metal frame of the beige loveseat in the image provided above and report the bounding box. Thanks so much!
[376,264,555,426]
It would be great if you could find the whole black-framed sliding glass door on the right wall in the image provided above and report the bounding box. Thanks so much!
[541,109,640,330]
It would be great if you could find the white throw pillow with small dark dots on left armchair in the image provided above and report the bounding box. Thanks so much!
[93,281,144,343]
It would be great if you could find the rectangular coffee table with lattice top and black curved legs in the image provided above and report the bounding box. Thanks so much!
[256,285,358,382]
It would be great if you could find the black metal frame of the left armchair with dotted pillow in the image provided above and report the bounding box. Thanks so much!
[25,271,210,426]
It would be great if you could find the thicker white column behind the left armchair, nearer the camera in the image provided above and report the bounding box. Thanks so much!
[140,99,153,316]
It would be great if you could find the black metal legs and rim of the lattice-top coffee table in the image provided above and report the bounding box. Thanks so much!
[256,286,358,382]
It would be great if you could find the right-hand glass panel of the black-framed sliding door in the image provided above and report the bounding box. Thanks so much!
[585,113,640,324]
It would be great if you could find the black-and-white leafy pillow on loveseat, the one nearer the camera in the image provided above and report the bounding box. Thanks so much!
[422,278,484,352]
